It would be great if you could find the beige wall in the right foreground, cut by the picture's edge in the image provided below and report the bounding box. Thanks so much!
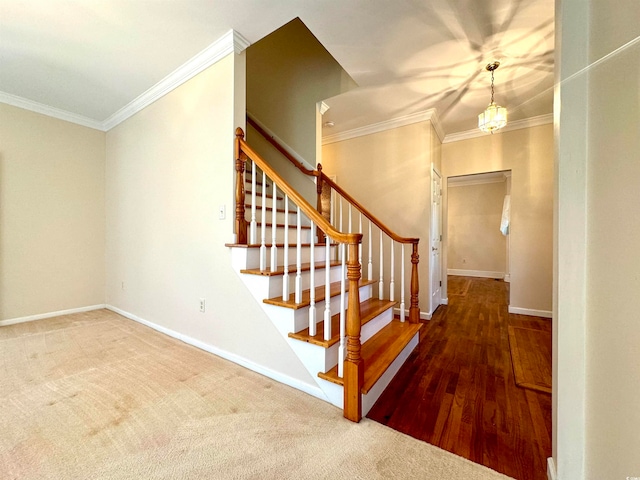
[585,0,640,480]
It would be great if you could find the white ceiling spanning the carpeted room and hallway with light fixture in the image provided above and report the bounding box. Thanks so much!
[0,0,554,138]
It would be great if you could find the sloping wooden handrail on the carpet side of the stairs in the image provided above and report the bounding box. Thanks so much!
[236,127,362,245]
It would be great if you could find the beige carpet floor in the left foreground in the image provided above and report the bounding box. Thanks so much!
[0,310,507,480]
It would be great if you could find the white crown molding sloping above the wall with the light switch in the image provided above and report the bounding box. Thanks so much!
[103,30,250,131]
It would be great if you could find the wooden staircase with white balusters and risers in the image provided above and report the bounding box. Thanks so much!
[228,127,422,422]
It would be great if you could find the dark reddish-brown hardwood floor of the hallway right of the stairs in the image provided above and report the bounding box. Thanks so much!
[367,277,551,480]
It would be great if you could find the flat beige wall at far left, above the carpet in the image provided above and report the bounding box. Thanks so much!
[0,104,105,321]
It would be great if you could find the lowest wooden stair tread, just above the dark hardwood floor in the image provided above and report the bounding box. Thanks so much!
[318,320,422,394]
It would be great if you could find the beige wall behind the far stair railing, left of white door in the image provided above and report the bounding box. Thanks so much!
[322,122,437,313]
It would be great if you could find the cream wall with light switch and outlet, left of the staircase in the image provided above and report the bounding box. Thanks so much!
[106,54,315,385]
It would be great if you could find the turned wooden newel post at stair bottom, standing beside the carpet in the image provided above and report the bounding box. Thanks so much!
[344,243,364,422]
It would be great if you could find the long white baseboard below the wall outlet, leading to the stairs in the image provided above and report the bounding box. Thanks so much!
[106,305,329,402]
